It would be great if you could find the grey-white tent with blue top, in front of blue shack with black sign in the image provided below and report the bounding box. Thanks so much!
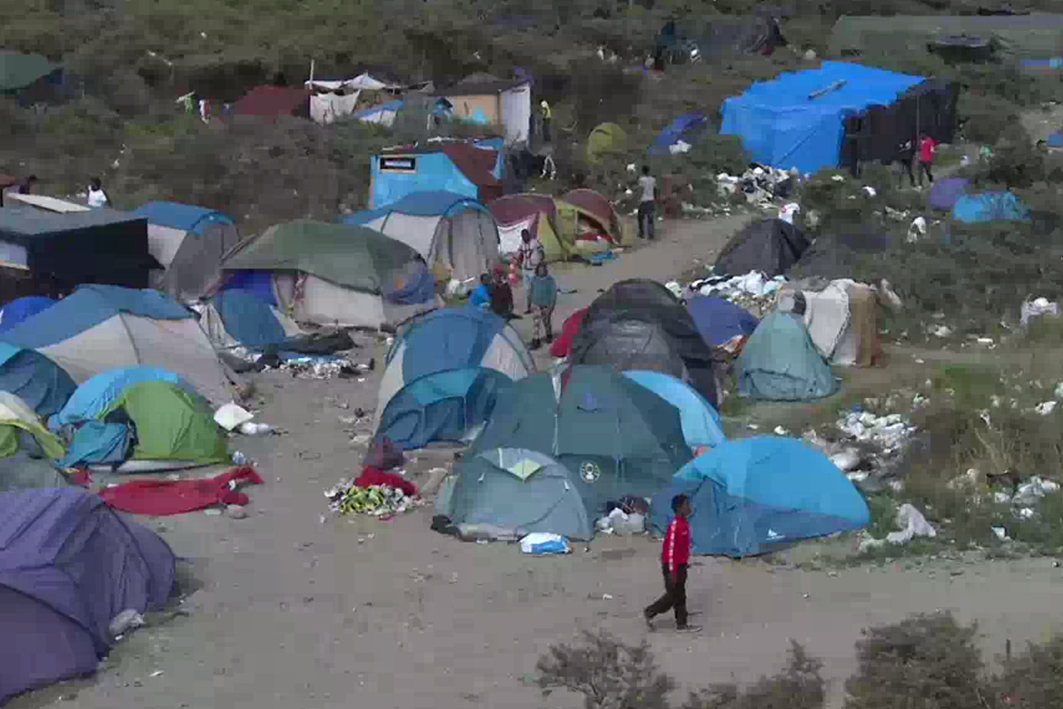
[343,191,499,281]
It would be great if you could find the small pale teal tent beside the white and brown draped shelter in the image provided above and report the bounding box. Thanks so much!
[738,311,838,401]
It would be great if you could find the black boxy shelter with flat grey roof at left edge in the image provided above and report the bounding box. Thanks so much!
[0,206,158,289]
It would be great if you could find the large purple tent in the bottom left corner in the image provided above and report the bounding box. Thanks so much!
[0,489,174,704]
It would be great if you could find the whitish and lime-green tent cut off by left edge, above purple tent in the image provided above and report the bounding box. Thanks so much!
[0,391,66,493]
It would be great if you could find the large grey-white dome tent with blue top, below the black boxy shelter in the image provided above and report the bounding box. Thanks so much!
[0,286,235,404]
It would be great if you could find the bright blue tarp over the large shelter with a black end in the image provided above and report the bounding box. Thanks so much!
[720,62,924,172]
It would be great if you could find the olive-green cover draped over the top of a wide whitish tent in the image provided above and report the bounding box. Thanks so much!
[222,220,418,293]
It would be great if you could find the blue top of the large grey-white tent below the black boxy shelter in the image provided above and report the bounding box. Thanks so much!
[0,286,195,350]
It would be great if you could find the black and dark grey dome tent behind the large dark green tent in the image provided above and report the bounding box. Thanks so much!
[570,278,716,406]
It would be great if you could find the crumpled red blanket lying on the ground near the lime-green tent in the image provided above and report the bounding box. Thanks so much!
[100,467,263,516]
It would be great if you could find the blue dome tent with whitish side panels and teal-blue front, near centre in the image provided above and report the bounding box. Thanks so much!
[376,307,535,449]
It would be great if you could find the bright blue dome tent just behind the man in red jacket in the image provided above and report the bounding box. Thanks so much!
[652,436,870,557]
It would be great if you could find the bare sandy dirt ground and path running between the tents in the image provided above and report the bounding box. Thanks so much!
[11,219,1061,709]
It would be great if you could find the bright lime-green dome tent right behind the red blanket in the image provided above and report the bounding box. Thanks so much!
[100,379,229,466]
